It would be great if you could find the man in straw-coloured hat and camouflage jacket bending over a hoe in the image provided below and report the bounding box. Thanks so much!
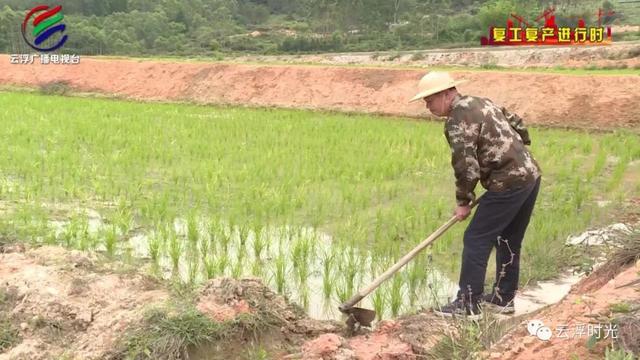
[411,72,540,317]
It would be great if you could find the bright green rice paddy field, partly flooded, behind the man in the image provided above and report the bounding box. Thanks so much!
[0,91,640,318]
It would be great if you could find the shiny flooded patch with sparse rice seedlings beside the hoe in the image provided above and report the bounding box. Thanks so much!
[42,210,457,319]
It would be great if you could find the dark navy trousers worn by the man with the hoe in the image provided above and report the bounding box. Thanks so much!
[458,177,540,301]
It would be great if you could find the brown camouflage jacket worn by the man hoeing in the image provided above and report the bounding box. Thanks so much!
[444,95,540,205]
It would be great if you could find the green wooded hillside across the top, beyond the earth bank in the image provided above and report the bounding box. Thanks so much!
[0,0,640,55]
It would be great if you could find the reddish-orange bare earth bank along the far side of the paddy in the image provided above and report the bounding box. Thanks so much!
[0,55,640,128]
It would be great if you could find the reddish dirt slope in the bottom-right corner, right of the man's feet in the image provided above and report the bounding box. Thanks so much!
[489,261,640,360]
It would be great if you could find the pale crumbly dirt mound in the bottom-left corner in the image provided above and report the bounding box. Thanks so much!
[0,247,167,360]
